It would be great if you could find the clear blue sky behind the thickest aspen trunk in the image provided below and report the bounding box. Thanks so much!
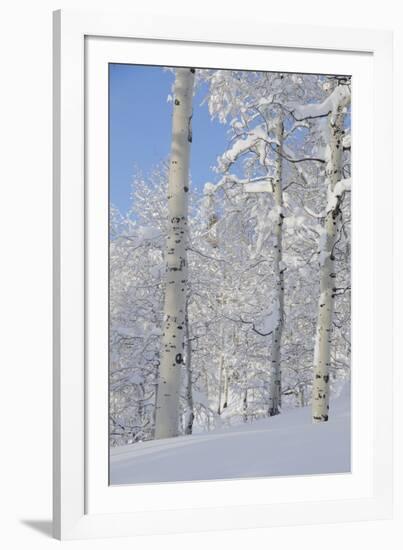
[109,64,228,213]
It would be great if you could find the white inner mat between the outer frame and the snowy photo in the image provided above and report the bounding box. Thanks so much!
[85,37,375,514]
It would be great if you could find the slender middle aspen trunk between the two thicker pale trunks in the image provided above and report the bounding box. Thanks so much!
[269,118,284,416]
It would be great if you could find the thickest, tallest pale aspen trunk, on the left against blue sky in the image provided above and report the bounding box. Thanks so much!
[155,69,195,439]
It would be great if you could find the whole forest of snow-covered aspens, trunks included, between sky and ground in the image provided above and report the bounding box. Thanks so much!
[109,69,351,447]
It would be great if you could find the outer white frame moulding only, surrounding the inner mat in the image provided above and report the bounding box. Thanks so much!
[54,10,392,539]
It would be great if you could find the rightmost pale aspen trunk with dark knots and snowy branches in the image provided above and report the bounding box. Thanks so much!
[312,86,346,423]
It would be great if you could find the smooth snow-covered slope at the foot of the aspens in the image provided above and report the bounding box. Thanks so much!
[110,392,350,485]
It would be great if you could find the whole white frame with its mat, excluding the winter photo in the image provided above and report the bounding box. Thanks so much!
[54,10,393,539]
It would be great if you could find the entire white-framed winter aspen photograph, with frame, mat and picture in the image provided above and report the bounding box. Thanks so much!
[54,10,393,539]
